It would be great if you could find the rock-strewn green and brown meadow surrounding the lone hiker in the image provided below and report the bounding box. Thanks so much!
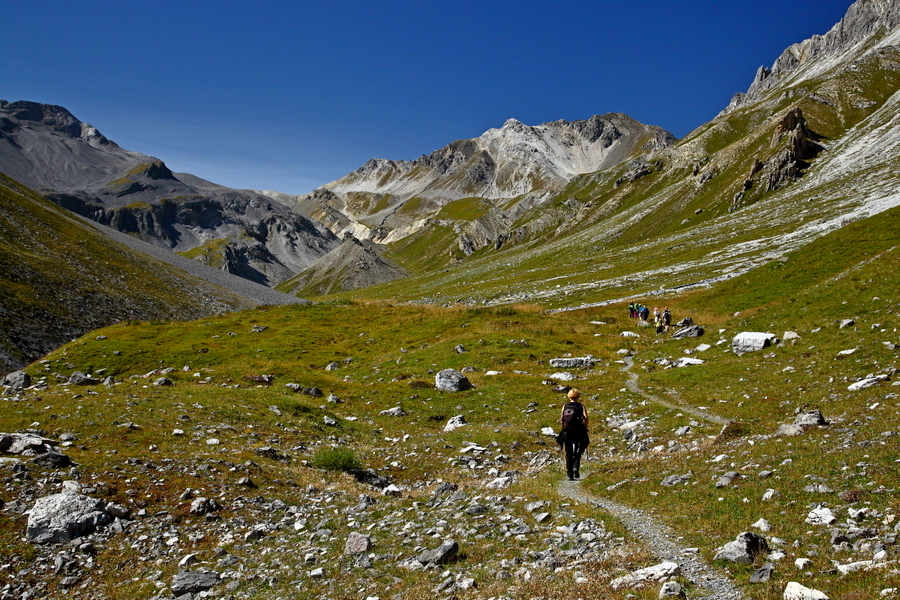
[0,204,900,600]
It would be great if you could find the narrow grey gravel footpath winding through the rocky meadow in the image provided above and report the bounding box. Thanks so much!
[558,357,744,600]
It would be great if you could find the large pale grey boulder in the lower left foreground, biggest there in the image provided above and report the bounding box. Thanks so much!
[26,494,113,544]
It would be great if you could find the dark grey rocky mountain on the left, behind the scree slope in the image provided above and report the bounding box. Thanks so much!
[0,101,339,285]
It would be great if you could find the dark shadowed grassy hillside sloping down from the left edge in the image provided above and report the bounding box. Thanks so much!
[0,174,250,371]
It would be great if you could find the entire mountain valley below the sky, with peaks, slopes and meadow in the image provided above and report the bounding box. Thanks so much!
[0,0,900,600]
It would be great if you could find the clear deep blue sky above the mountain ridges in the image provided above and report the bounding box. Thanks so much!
[0,0,851,194]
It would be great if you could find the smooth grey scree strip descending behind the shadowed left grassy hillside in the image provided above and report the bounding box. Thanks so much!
[81,213,310,306]
